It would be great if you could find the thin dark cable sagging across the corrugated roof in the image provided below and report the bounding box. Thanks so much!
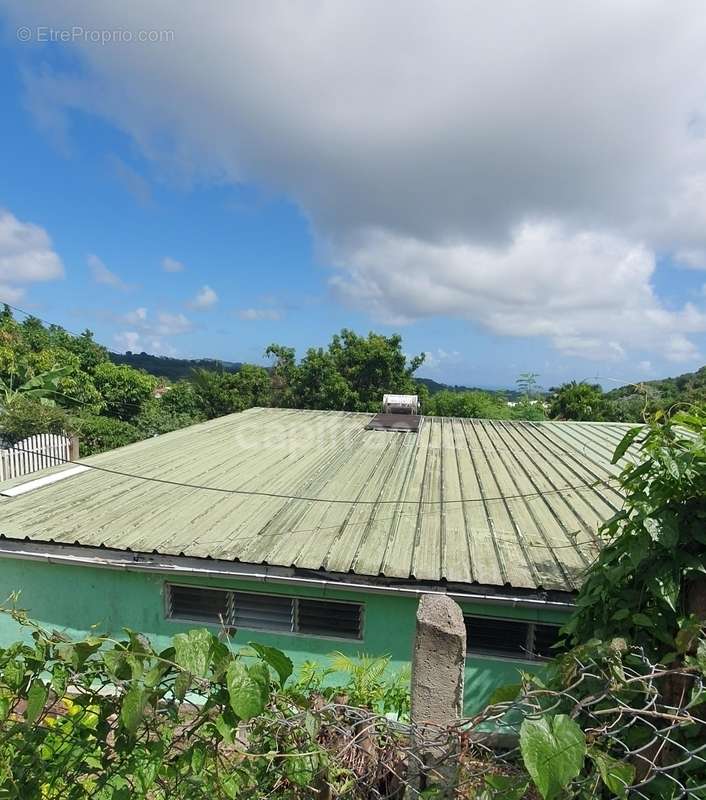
[6,446,618,506]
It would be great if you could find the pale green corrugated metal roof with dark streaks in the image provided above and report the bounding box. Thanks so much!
[0,409,630,591]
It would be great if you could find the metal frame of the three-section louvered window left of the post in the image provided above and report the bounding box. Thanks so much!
[163,581,365,642]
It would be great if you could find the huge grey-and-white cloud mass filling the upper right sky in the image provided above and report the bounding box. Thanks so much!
[8,0,706,360]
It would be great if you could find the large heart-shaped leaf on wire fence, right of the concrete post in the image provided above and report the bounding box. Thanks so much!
[520,714,586,800]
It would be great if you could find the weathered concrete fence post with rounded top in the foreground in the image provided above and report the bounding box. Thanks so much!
[410,594,466,797]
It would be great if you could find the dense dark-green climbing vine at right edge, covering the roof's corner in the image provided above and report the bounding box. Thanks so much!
[565,410,706,657]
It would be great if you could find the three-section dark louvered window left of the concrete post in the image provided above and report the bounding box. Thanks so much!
[167,584,363,639]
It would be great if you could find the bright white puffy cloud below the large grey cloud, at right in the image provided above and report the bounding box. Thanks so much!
[332,224,706,361]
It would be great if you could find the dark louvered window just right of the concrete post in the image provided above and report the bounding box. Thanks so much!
[463,616,559,661]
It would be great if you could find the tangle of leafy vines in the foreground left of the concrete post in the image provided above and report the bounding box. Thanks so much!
[0,612,408,800]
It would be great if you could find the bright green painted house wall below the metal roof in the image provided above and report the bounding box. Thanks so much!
[0,557,564,713]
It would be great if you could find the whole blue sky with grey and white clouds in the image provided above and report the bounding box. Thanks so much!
[0,0,706,387]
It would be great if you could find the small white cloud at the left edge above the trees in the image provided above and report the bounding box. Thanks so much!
[0,209,64,303]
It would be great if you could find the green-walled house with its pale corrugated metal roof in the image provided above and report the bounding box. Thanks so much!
[0,408,627,710]
